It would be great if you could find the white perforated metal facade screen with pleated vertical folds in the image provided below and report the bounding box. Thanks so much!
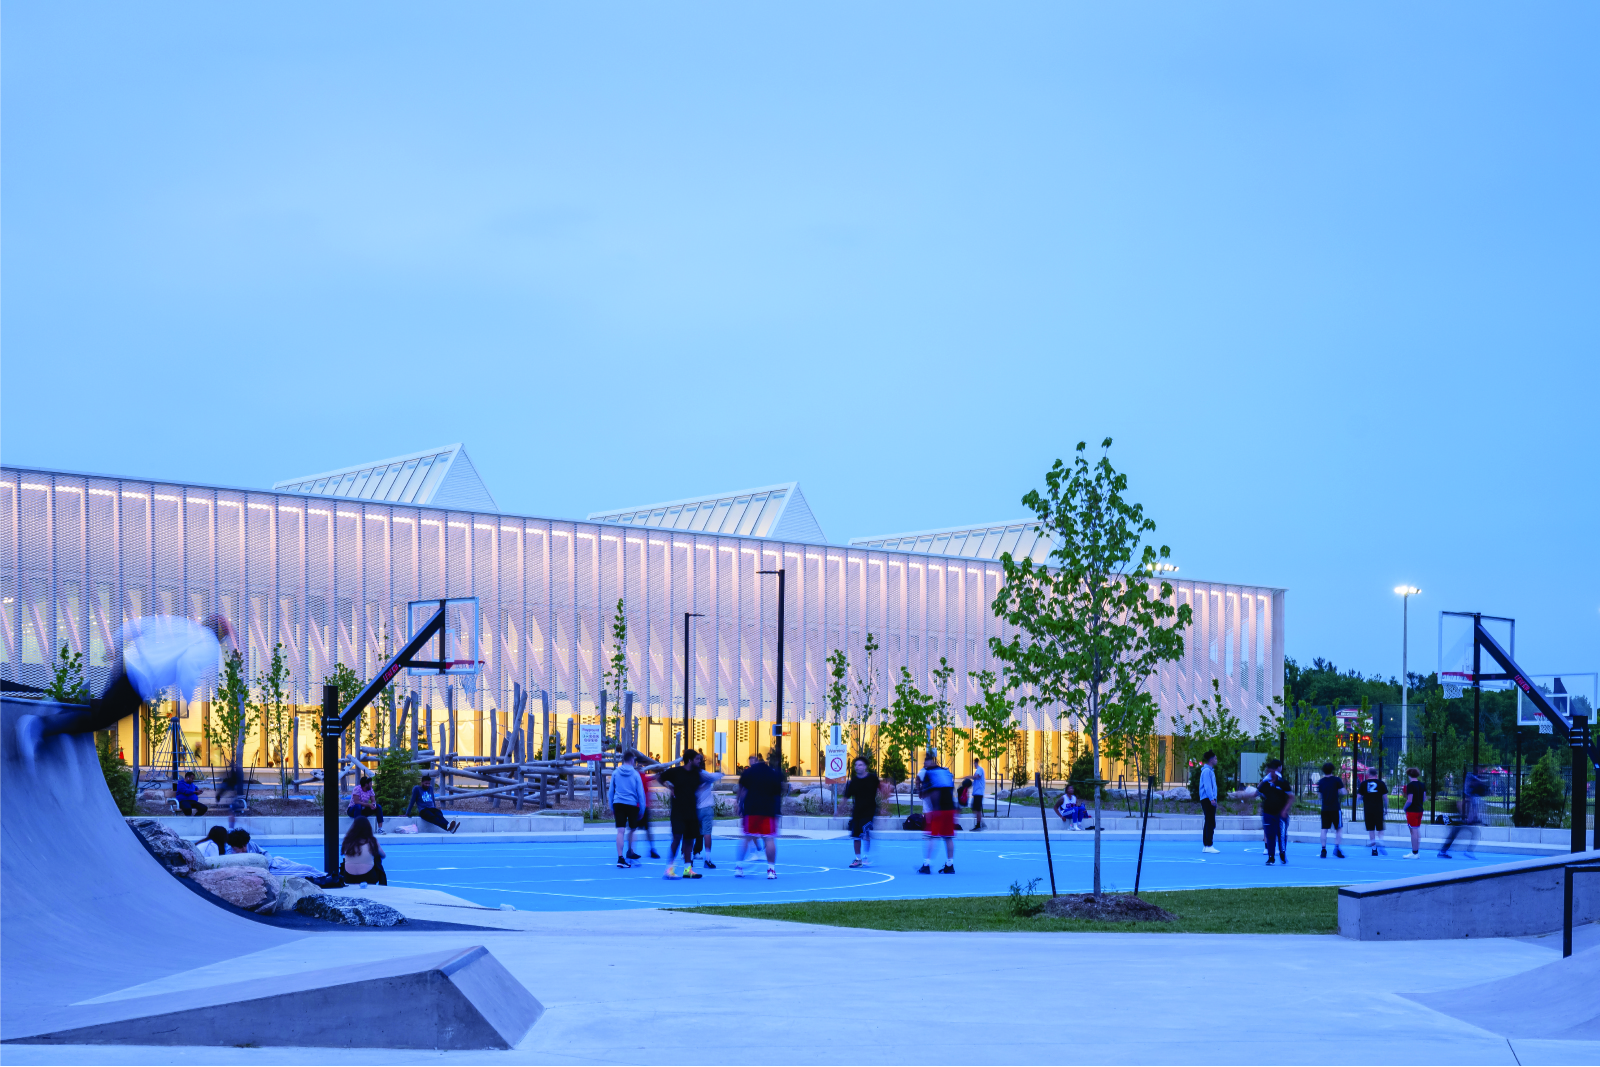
[0,467,1283,771]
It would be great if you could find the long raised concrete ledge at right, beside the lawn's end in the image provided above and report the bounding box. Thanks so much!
[1339,851,1600,941]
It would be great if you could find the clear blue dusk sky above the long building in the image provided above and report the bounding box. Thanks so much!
[0,0,1600,675]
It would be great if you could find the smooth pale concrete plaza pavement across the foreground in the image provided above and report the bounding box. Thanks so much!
[5,889,1600,1064]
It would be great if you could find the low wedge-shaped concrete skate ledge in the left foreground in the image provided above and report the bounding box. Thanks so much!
[6,945,544,1049]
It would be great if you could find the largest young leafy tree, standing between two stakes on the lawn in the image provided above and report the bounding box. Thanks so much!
[989,437,1192,896]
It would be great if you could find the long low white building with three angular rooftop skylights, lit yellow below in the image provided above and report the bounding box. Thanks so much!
[0,445,1283,774]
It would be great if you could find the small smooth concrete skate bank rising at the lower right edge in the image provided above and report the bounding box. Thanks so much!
[1410,949,1600,1041]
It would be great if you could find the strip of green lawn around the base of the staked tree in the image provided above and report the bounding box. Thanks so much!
[683,886,1339,934]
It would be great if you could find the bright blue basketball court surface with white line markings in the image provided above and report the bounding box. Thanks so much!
[274,835,1512,912]
